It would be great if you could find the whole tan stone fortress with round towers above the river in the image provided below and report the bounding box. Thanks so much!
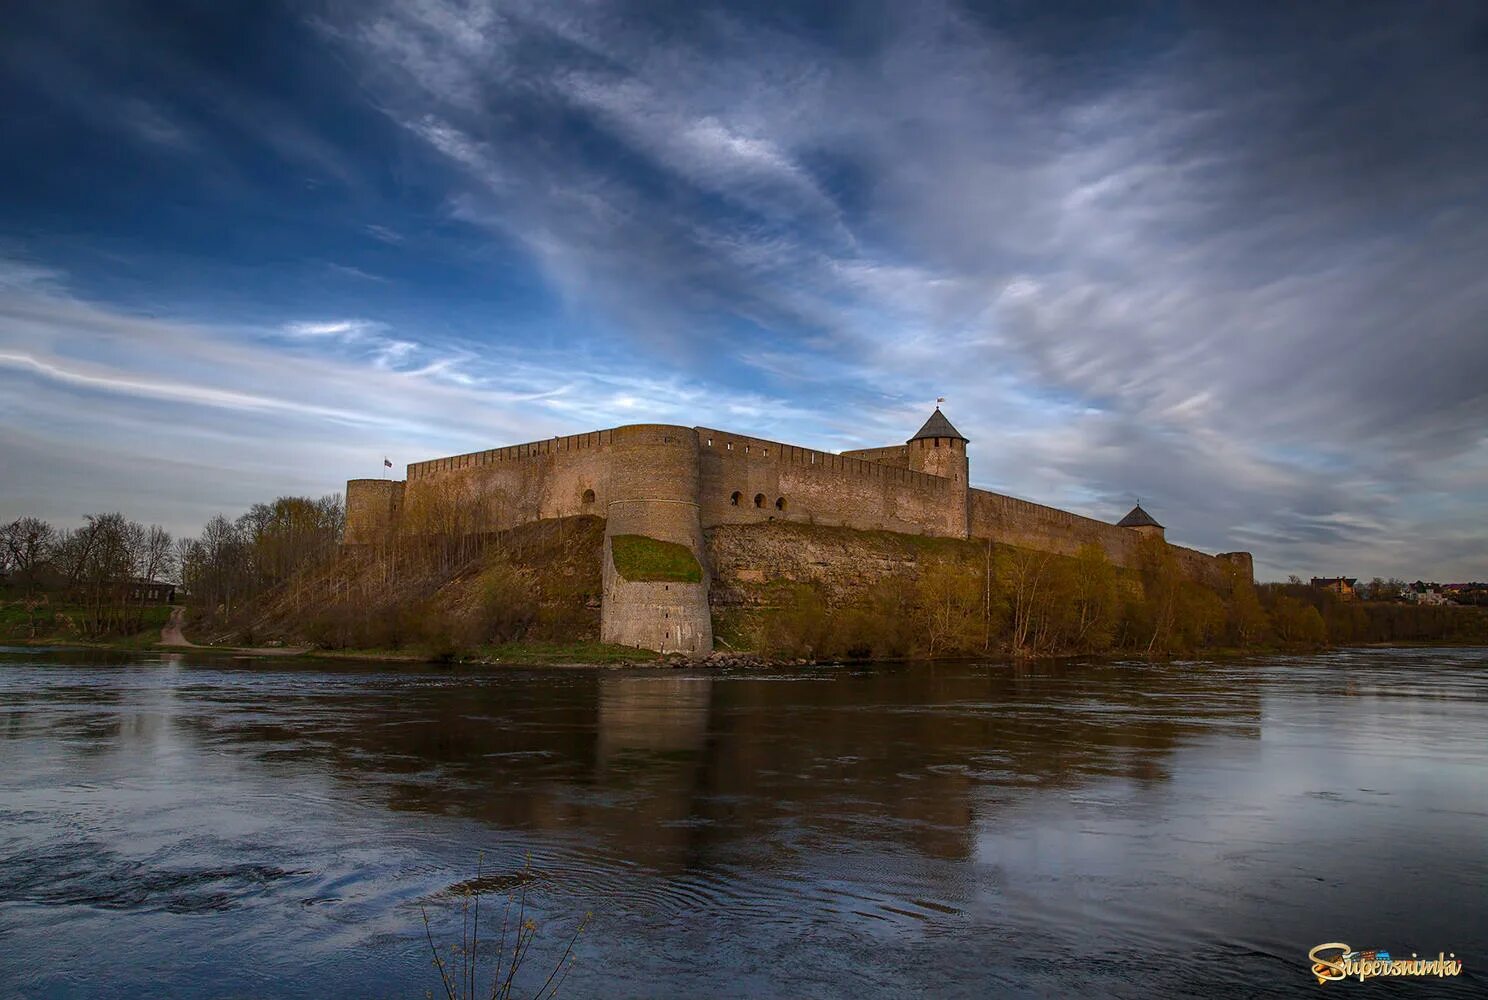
[345,408,1251,653]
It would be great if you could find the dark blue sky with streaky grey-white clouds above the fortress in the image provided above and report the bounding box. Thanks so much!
[0,0,1488,580]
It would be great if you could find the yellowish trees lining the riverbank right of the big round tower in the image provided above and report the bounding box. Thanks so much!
[749,539,1488,658]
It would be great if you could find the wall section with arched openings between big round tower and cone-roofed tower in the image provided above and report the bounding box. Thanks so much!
[696,427,964,536]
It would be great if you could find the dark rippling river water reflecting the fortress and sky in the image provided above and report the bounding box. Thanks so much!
[0,649,1488,997]
